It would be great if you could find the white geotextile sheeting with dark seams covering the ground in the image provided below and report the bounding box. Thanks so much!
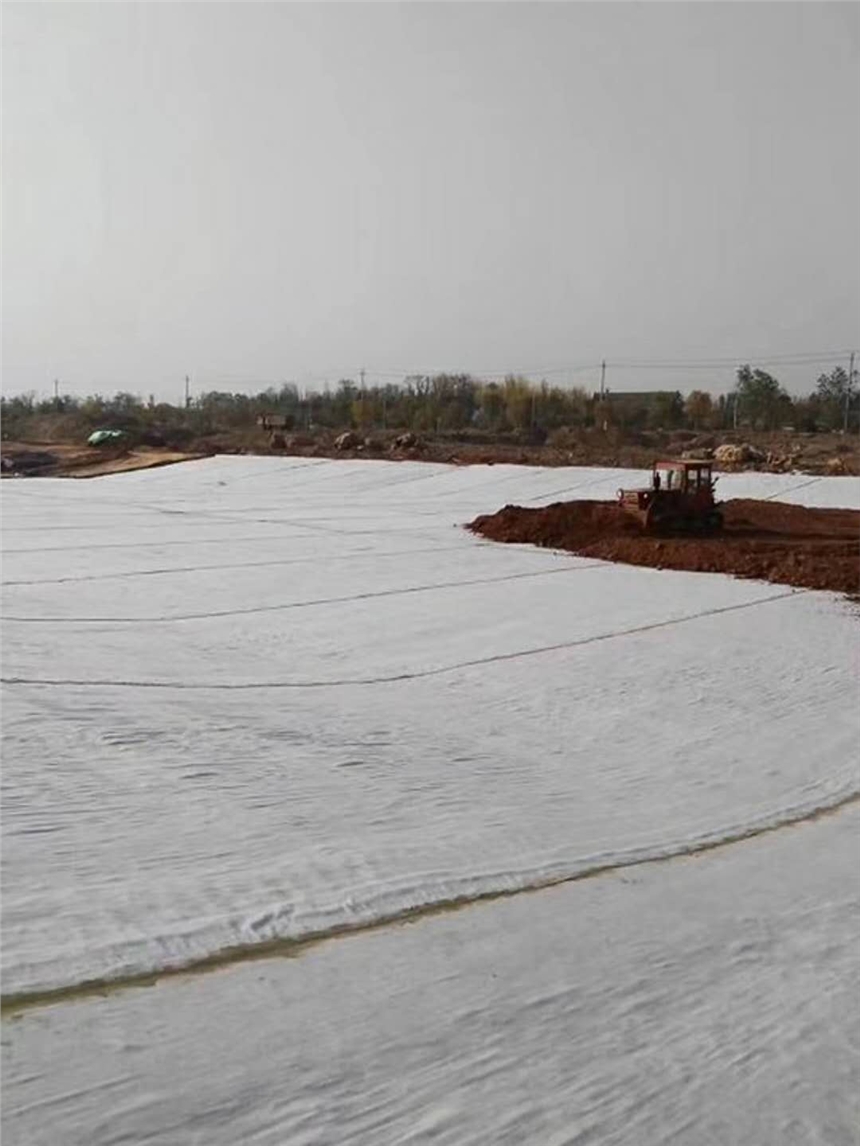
[0,456,860,1146]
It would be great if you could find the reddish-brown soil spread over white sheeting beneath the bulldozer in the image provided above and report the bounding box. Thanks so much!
[468,499,860,596]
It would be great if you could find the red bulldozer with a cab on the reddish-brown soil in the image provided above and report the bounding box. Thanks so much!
[618,458,722,533]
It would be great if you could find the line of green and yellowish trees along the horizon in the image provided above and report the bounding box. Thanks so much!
[0,366,860,445]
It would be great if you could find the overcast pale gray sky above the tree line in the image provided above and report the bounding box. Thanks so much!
[2,2,860,399]
